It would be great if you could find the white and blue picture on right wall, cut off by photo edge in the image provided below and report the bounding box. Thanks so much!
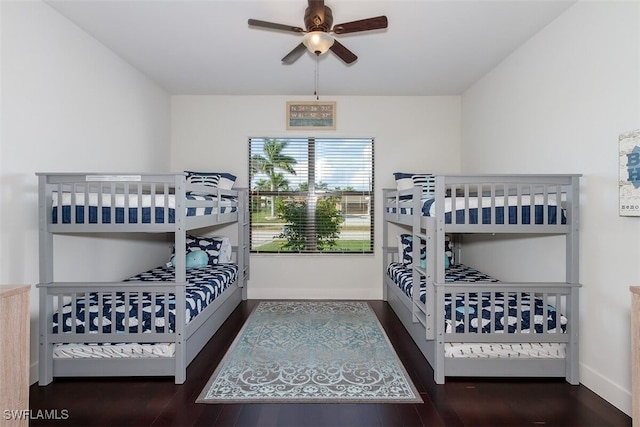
[618,129,640,216]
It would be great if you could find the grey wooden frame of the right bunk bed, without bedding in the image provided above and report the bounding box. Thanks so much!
[383,175,581,385]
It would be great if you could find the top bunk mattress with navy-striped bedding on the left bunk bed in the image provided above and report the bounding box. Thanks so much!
[51,192,237,224]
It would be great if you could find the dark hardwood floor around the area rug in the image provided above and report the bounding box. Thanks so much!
[30,301,631,427]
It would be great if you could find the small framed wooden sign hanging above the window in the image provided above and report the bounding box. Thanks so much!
[287,101,336,130]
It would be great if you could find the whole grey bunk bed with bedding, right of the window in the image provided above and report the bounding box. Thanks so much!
[383,174,580,385]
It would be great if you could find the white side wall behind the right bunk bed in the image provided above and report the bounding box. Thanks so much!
[461,1,640,414]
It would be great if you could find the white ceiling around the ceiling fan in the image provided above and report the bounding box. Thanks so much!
[45,0,575,96]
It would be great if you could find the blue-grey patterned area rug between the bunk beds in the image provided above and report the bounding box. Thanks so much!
[196,301,422,403]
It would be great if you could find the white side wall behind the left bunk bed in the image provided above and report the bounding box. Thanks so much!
[0,1,170,381]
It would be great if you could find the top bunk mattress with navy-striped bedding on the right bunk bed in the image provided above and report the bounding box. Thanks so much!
[387,195,566,224]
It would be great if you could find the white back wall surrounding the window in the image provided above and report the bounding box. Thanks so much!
[171,96,460,299]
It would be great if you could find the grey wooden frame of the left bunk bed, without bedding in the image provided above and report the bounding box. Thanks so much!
[36,173,249,385]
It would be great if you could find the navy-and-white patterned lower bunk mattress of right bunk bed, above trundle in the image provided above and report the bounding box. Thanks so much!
[387,263,567,333]
